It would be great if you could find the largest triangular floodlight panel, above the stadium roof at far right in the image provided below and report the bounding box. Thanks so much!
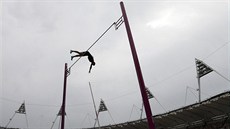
[195,59,213,78]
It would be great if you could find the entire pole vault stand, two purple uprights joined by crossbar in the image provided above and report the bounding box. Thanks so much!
[61,2,155,129]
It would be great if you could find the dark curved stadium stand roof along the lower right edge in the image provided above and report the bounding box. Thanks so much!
[89,91,230,129]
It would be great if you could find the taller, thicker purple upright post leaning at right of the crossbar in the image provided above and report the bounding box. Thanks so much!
[120,2,155,129]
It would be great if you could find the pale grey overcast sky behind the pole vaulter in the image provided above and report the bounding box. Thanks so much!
[0,0,230,129]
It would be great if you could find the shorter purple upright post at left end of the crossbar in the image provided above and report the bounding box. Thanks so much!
[61,63,68,129]
